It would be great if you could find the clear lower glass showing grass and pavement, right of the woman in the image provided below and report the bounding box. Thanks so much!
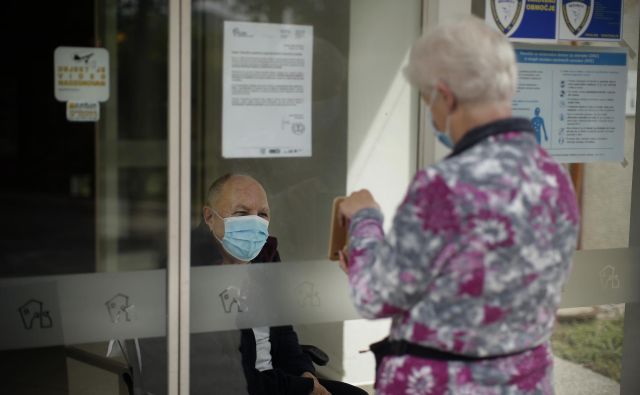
[551,304,624,395]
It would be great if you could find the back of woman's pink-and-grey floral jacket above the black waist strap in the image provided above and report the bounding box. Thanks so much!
[400,129,578,356]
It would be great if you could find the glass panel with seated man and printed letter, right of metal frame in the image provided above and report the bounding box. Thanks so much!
[190,0,421,394]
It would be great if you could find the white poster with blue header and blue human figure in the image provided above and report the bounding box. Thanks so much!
[513,45,627,163]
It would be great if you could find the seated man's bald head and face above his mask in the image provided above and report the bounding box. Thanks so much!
[203,176,270,240]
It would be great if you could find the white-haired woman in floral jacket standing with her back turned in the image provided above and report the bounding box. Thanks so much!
[340,18,579,395]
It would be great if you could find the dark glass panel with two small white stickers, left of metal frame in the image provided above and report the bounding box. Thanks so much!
[0,0,168,394]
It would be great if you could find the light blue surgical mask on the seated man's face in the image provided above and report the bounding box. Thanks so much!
[212,210,269,262]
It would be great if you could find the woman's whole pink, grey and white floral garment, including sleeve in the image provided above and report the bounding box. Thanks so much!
[349,123,579,395]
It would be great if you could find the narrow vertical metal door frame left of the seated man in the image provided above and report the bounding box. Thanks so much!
[167,0,191,395]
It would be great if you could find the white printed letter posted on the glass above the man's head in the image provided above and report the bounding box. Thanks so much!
[222,21,313,158]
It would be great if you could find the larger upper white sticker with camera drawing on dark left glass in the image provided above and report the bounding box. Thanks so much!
[53,47,109,102]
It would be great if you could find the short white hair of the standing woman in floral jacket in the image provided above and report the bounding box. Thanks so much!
[405,17,518,102]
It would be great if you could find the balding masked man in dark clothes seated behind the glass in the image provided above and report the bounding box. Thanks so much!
[191,174,366,395]
